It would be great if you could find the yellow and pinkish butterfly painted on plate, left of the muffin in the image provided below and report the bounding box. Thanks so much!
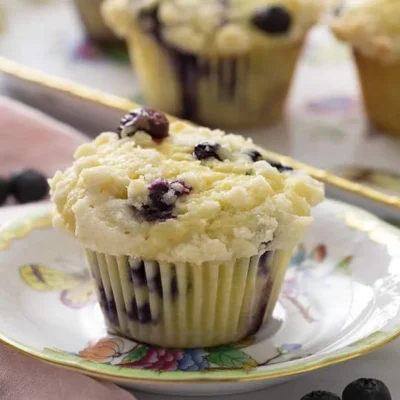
[19,263,96,309]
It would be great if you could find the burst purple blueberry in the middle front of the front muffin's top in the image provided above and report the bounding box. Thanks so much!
[138,179,192,222]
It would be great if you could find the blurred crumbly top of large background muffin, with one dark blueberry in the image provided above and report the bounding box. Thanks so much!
[103,0,322,56]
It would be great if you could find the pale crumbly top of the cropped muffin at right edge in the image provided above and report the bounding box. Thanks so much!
[331,0,400,62]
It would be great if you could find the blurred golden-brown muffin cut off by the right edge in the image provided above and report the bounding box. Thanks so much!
[331,0,400,136]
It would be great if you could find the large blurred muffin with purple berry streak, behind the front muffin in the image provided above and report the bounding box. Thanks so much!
[103,0,321,129]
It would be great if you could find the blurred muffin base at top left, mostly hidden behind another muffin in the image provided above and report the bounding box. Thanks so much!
[74,0,121,45]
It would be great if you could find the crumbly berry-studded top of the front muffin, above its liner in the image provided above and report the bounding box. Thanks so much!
[50,109,323,264]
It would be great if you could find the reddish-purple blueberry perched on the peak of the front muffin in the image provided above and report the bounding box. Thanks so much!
[117,108,169,139]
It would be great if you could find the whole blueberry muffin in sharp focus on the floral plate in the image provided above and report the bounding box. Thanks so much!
[50,109,323,348]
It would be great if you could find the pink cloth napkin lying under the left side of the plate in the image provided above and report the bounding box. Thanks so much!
[0,97,134,400]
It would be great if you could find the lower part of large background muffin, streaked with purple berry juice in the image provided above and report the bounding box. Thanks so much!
[128,30,302,129]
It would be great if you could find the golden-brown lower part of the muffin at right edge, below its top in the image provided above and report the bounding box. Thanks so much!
[354,51,400,136]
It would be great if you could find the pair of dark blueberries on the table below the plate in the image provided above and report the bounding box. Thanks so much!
[301,378,392,400]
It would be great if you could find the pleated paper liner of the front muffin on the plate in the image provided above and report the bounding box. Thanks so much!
[86,250,291,348]
